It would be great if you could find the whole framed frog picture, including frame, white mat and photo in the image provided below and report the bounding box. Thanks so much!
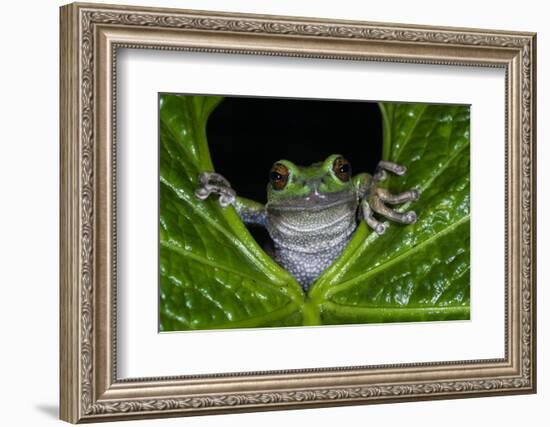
[60,4,536,423]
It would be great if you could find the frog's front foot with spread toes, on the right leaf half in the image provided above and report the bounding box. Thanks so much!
[361,161,420,234]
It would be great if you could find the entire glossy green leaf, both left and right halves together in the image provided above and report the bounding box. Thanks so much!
[160,95,470,331]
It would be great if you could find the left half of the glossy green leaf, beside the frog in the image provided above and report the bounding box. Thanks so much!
[159,95,304,331]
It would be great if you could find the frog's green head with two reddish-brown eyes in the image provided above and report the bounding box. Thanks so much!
[267,154,356,210]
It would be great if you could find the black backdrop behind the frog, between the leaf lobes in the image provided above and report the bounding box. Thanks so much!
[207,97,382,247]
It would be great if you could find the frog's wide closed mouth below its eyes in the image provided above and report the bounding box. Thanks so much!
[267,191,357,212]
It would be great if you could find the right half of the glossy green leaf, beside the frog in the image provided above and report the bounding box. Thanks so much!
[308,103,470,324]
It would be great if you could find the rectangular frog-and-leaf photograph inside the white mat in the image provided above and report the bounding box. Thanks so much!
[159,94,470,332]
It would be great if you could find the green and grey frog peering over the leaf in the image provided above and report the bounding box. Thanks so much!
[195,154,420,292]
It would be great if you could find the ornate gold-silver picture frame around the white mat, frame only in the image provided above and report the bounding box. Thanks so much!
[60,4,536,423]
